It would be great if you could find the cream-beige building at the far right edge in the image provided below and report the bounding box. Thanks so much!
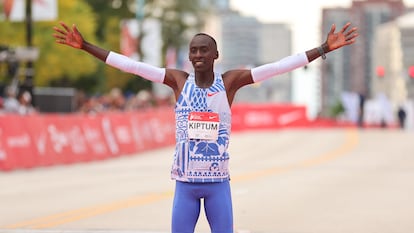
[371,13,414,128]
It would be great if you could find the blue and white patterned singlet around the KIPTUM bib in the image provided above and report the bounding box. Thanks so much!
[171,73,231,183]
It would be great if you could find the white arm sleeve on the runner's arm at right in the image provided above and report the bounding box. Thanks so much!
[251,52,309,82]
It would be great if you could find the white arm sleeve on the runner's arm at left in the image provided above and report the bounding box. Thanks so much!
[105,51,165,83]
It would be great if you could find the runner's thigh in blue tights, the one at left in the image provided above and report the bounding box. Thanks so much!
[172,181,200,233]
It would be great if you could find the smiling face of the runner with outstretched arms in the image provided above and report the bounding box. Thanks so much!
[189,35,218,72]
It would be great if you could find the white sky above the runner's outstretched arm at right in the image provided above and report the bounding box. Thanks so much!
[230,0,414,53]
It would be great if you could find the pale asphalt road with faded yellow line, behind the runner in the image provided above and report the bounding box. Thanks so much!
[0,129,414,233]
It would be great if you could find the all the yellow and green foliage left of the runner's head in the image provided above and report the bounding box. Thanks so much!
[0,0,208,94]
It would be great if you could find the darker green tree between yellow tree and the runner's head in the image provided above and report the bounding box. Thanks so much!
[89,0,209,92]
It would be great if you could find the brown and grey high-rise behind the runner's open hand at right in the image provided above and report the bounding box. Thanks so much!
[321,0,406,113]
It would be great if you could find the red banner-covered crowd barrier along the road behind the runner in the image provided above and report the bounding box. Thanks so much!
[0,104,350,171]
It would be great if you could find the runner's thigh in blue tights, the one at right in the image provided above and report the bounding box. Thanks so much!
[204,181,233,233]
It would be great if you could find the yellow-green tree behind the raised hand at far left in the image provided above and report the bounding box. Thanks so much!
[0,0,97,86]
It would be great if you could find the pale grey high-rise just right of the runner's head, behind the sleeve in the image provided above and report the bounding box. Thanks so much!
[205,8,292,103]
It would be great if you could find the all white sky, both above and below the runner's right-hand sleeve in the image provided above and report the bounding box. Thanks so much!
[230,0,414,118]
